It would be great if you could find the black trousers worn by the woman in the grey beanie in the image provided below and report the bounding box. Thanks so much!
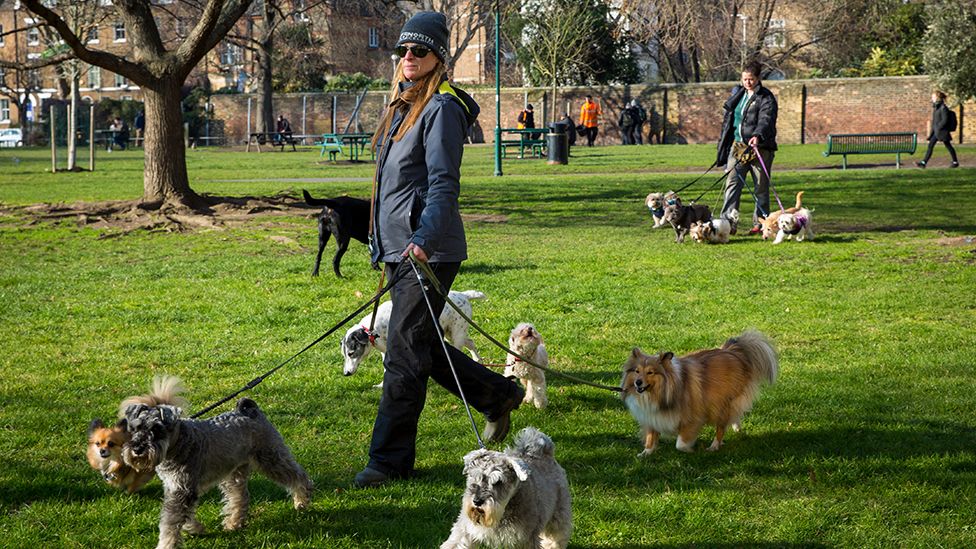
[369,261,518,477]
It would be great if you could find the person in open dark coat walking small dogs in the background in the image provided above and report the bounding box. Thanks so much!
[715,62,779,234]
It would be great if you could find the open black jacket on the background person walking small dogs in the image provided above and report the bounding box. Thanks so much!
[715,85,779,166]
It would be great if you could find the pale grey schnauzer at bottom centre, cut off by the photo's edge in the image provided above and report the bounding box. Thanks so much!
[441,427,573,549]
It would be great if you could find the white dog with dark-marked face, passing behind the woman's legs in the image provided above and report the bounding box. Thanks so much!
[340,290,485,376]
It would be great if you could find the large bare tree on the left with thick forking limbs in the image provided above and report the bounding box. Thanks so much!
[24,0,251,209]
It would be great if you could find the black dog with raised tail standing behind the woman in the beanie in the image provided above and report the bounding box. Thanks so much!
[302,189,369,278]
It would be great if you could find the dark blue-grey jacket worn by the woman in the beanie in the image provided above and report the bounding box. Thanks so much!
[370,78,480,263]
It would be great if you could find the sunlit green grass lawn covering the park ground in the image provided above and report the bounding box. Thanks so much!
[0,145,976,549]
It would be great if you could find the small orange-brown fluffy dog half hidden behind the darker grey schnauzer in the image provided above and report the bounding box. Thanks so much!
[87,376,188,494]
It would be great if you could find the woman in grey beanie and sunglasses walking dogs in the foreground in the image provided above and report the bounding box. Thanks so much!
[354,12,525,487]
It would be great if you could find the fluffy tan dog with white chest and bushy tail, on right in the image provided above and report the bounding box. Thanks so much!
[621,331,779,456]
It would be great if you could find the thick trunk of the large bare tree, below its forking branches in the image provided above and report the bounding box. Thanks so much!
[142,78,206,210]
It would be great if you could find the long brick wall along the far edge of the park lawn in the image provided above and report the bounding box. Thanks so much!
[213,76,976,148]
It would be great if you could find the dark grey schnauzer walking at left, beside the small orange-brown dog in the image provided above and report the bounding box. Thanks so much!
[122,398,312,549]
